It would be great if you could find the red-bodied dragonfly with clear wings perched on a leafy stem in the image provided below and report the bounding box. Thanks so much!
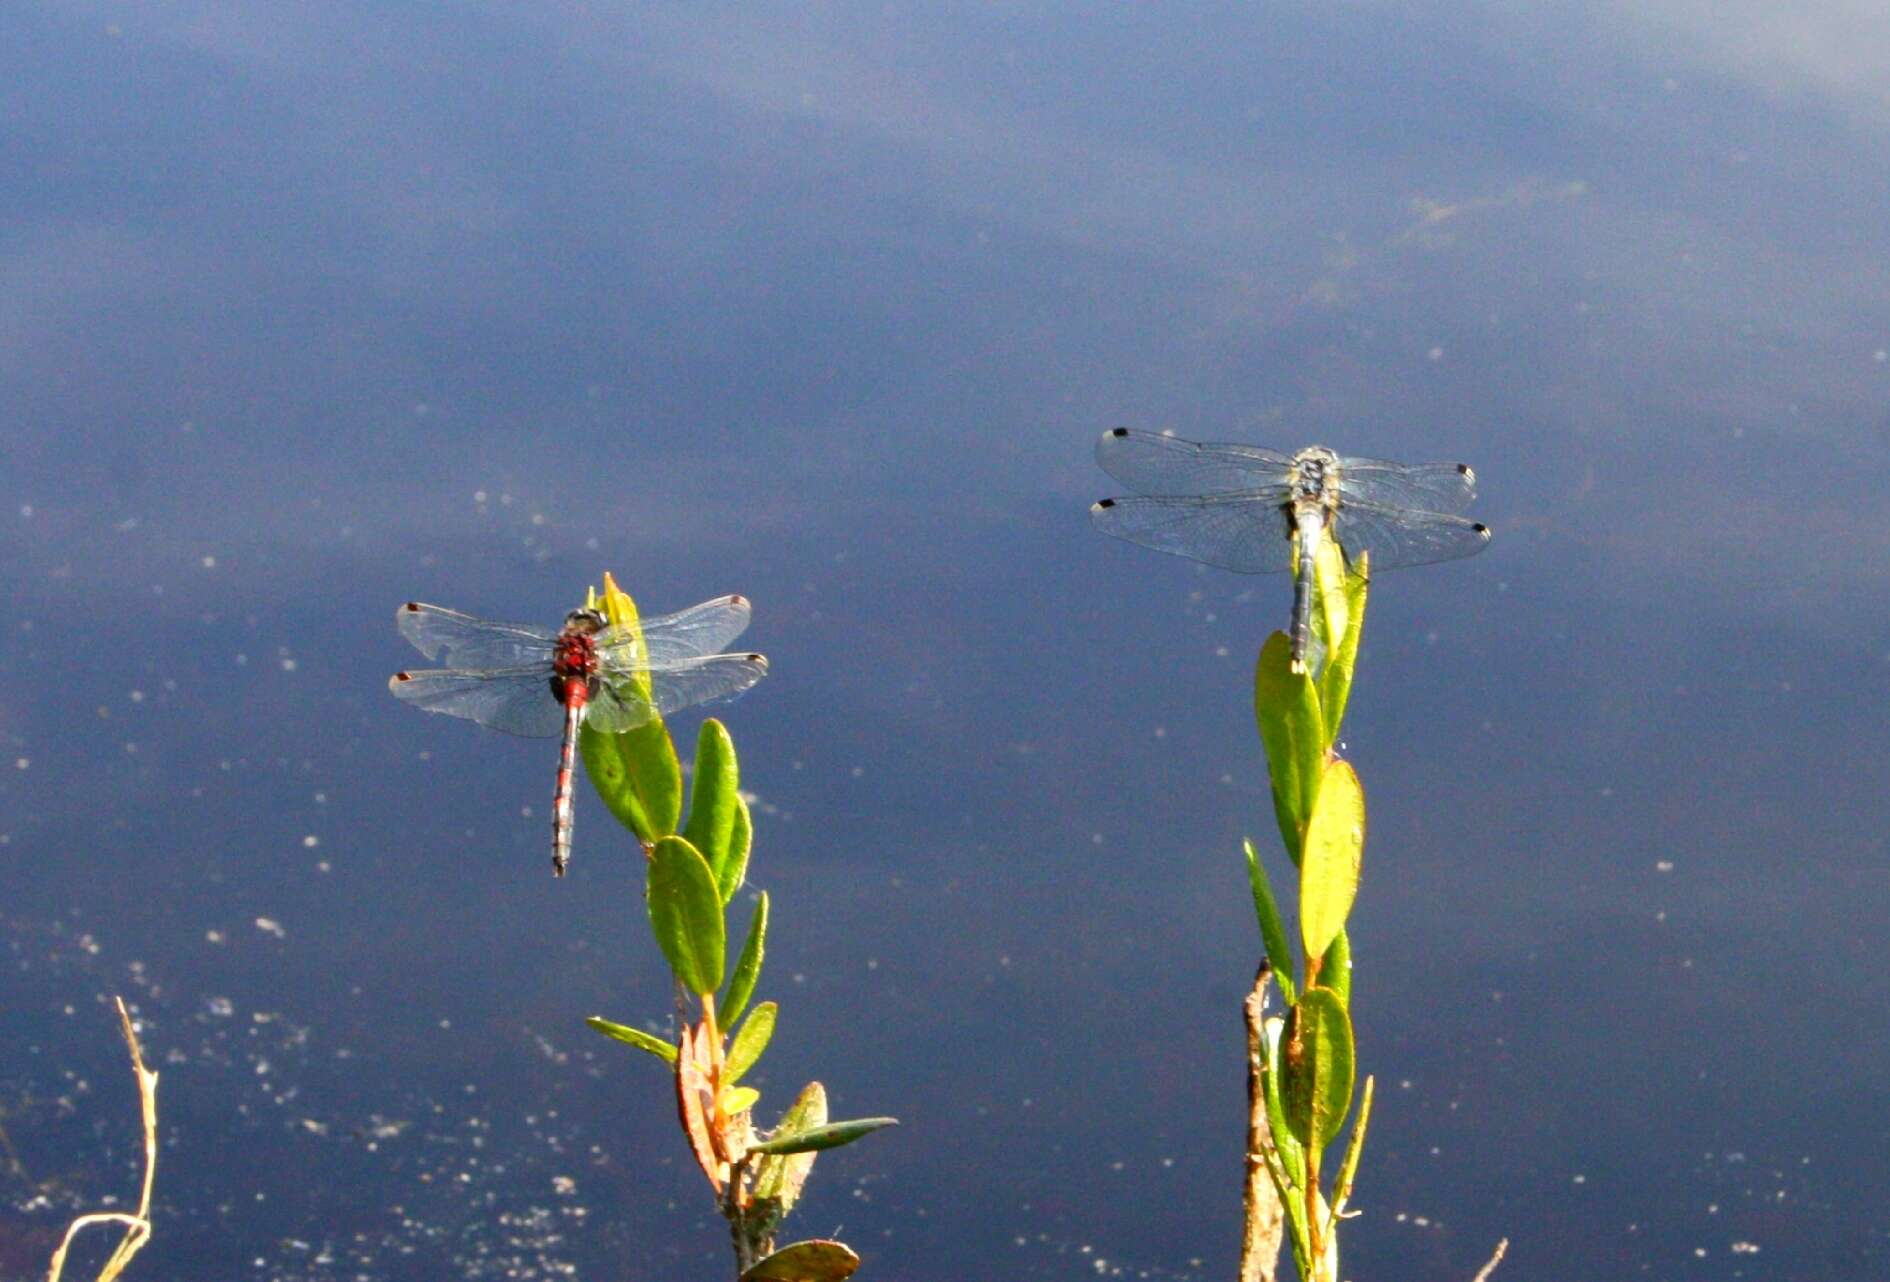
[387,596,767,877]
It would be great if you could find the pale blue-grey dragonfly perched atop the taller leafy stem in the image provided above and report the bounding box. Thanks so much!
[1089,427,1489,671]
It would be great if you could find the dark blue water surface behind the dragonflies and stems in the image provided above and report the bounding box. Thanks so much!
[0,0,1890,1282]
